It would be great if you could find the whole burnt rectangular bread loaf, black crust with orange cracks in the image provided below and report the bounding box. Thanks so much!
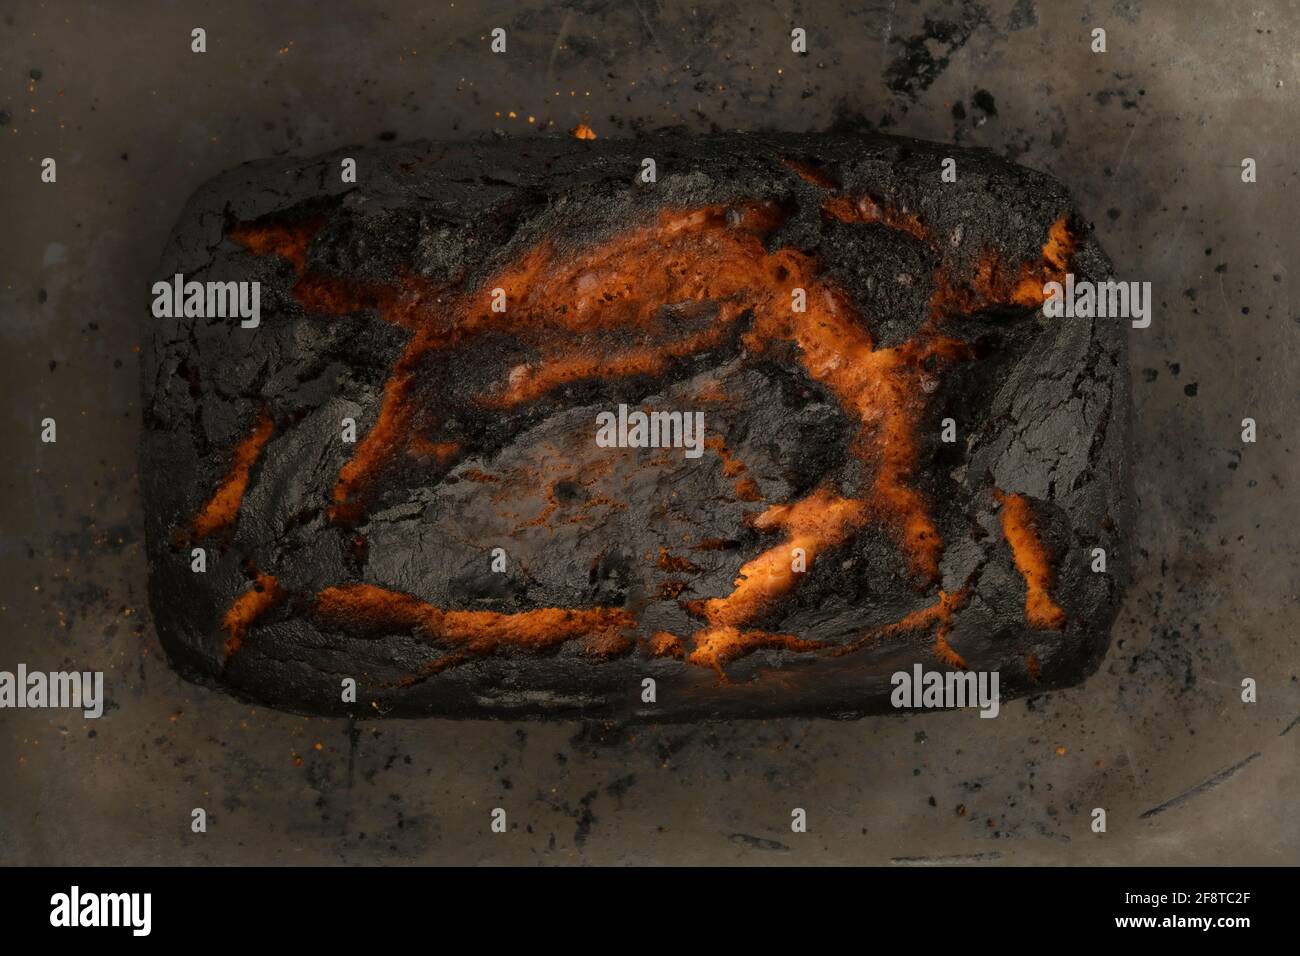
[140,134,1130,719]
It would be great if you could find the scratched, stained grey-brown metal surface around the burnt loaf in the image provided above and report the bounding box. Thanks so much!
[0,0,1300,865]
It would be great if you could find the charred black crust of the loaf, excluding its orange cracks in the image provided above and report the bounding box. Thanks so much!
[140,134,1132,721]
